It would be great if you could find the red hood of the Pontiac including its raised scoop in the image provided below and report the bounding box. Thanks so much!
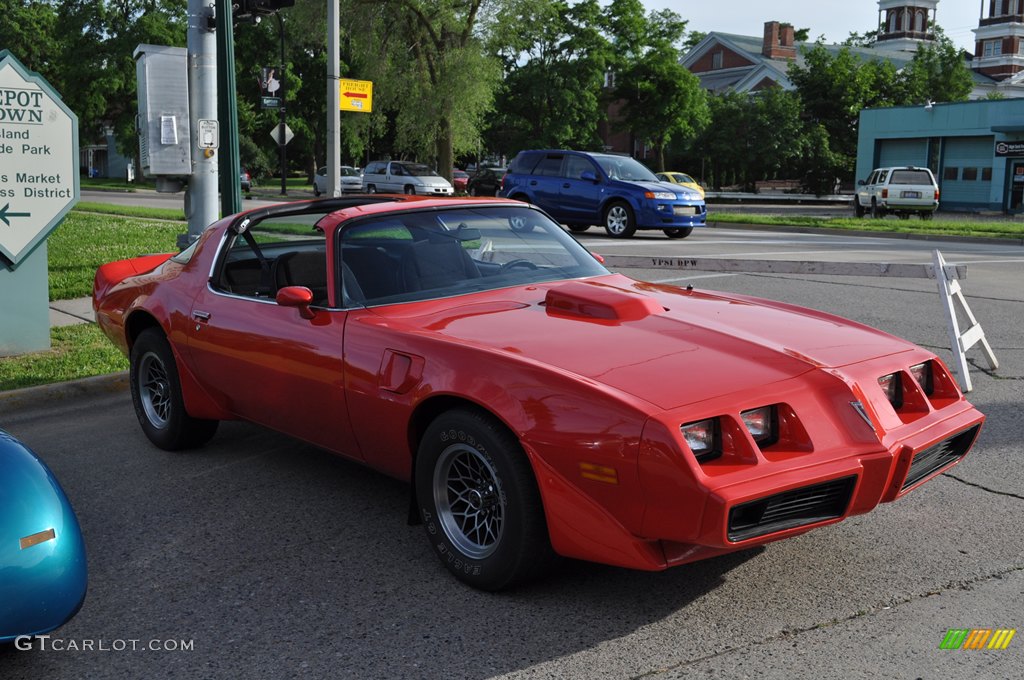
[382,274,914,409]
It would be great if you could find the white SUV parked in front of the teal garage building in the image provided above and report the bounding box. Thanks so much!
[853,166,939,219]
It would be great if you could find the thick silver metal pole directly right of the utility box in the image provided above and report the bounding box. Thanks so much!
[181,0,218,245]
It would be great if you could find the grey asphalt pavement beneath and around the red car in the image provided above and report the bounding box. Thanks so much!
[0,228,1024,680]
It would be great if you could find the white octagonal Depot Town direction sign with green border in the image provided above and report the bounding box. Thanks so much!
[0,50,80,266]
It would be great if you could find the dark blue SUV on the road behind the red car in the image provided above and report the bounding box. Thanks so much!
[499,150,708,239]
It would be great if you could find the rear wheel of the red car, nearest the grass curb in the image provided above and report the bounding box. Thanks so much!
[129,328,219,451]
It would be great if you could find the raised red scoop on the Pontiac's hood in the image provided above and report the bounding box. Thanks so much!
[544,281,666,324]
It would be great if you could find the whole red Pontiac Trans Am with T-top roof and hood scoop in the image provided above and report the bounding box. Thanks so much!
[93,196,984,590]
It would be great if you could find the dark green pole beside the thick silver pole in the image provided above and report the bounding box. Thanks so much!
[216,0,242,215]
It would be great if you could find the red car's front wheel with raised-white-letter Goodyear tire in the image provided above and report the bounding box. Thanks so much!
[415,409,554,591]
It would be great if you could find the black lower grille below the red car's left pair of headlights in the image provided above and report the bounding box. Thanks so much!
[728,475,857,542]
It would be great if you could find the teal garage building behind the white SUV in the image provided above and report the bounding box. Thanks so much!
[855,98,1024,214]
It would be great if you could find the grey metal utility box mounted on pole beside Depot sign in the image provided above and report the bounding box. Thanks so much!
[133,44,193,193]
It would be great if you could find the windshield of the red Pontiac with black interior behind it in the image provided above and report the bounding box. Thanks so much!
[340,206,607,306]
